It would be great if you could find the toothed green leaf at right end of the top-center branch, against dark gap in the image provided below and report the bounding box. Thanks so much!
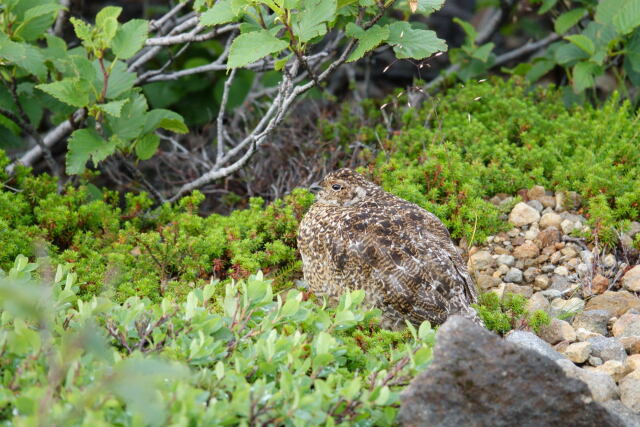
[387,22,447,59]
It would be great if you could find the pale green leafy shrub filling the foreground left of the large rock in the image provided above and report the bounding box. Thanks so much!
[0,257,434,426]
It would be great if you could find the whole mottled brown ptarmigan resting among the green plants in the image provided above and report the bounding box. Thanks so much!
[298,169,480,327]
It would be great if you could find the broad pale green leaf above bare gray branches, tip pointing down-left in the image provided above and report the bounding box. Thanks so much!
[227,30,289,68]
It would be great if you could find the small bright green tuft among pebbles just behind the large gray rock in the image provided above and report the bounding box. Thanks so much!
[473,292,551,334]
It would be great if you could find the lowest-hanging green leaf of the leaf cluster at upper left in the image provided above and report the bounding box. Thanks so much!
[66,129,117,175]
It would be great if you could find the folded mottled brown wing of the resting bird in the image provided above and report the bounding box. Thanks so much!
[332,202,475,323]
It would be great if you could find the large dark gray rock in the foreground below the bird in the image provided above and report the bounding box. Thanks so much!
[399,316,624,426]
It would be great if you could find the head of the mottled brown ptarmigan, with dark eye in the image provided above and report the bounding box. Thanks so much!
[309,168,382,207]
